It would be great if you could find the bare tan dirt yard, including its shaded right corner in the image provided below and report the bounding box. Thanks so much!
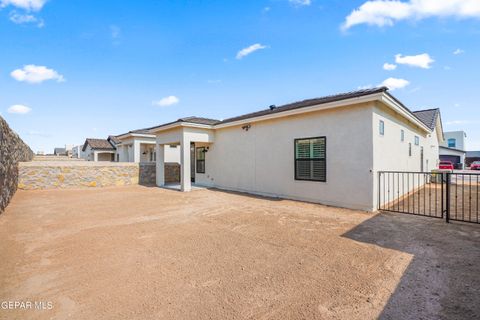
[0,186,480,320]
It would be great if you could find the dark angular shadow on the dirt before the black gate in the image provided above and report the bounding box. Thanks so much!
[343,213,480,319]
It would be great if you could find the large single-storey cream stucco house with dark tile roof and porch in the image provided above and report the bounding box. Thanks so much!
[149,87,443,211]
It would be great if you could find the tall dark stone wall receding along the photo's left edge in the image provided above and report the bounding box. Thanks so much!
[0,117,33,213]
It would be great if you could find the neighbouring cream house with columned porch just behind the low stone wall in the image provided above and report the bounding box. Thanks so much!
[115,128,180,163]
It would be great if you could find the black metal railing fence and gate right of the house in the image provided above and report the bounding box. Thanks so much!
[378,171,480,223]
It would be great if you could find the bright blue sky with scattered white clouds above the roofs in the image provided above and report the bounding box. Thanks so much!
[0,0,480,152]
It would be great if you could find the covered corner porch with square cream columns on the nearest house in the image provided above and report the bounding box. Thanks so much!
[156,126,214,192]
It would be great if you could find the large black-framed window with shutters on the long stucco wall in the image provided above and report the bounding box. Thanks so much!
[295,137,327,182]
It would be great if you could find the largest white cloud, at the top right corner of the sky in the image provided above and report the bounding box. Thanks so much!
[341,0,480,31]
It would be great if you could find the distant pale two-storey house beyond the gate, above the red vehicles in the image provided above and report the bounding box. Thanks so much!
[440,131,467,169]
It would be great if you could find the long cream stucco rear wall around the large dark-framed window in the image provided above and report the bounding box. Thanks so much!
[195,104,374,210]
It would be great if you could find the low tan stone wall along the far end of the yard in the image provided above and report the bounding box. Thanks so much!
[18,161,180,190]
